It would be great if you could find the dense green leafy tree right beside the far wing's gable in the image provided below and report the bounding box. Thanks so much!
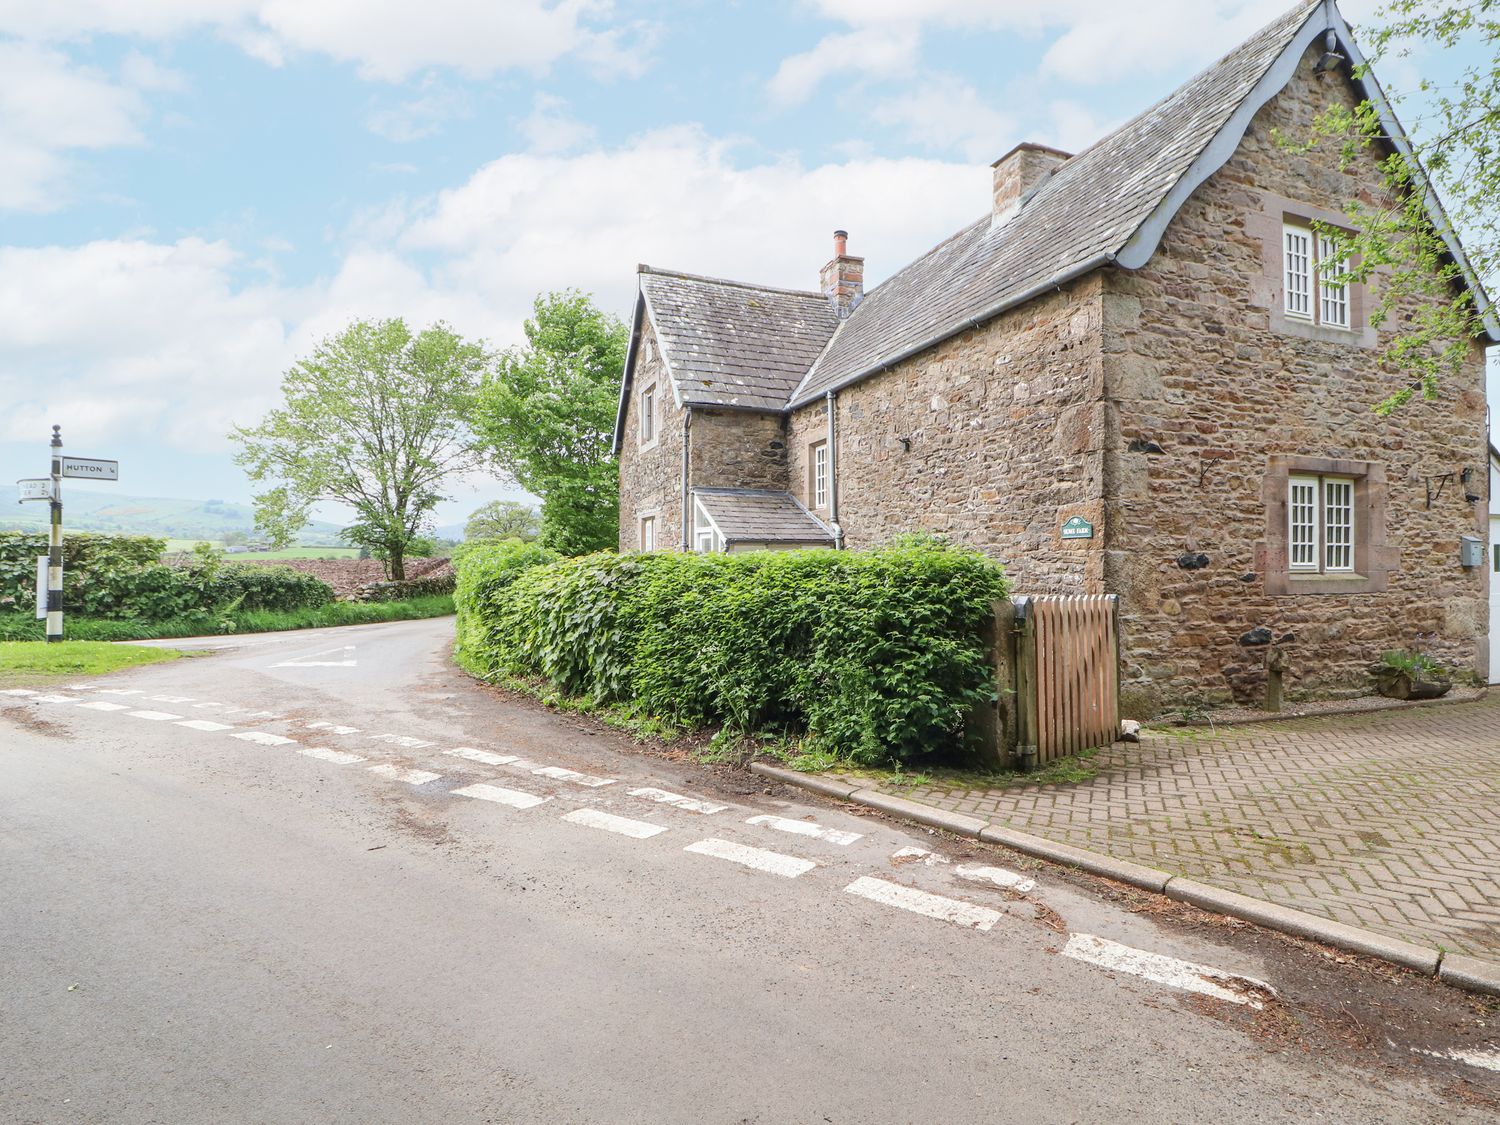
[474,290,629,555]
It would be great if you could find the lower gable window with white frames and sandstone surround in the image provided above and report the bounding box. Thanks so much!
[1257,455,1395,596]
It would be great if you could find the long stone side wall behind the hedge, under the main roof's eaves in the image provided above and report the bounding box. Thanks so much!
[788,278,1104,594]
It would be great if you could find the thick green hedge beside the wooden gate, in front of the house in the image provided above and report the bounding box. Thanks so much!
[455,540,1007,764]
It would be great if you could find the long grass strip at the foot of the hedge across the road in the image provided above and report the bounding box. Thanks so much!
[0,594,453,648]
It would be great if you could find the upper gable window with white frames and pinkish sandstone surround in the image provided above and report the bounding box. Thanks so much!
[1245,192,1379,350]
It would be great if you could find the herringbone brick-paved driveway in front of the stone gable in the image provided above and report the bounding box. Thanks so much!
[900,705,1500,959]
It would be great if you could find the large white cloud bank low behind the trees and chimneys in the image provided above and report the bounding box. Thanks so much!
[0,129,987,455]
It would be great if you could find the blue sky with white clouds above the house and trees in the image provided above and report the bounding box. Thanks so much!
[0,0,1452,534]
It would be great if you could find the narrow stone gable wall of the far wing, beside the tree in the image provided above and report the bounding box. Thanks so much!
[620,321,686,551]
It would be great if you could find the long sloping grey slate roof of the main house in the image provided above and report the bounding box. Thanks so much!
[791,0,1323,407]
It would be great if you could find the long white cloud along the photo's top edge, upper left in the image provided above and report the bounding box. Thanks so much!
[0,0,650,81]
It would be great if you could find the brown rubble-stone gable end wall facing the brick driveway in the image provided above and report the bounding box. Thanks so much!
[1104,51,1488,713]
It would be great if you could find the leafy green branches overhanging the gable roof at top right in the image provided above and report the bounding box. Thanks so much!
[1311,0,1500,414]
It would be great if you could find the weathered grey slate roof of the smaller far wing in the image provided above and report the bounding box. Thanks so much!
[641,266,839,410]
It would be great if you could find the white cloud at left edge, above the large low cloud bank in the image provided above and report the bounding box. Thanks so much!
[0,41,146,212]
